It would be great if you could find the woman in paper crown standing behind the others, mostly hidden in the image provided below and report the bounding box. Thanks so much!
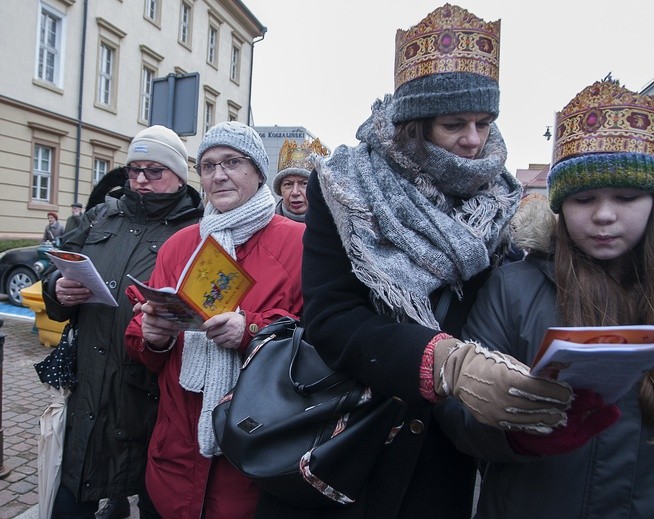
[273,139,329,222]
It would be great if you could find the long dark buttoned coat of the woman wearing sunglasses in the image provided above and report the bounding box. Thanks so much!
[43,186,202,501]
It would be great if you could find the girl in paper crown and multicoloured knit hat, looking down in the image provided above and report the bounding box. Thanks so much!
[439,81,654,519]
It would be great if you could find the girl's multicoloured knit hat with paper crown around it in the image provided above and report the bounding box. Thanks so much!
[547,81,654,213]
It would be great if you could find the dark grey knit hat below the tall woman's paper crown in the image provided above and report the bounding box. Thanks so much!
[390,72,500,124]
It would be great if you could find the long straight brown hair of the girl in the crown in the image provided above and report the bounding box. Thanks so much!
[554,210,654,424]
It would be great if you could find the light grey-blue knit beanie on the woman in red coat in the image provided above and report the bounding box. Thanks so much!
[197,121,269,182]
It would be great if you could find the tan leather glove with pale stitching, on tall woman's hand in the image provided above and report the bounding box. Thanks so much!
[434,339,573,434]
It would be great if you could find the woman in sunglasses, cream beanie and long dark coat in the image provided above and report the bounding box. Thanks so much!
[43,125,202,519]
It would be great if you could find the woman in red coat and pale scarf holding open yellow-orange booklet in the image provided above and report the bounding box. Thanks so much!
[126,122,304,519]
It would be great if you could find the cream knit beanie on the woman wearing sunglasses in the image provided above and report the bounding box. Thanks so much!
[126,125,188,184]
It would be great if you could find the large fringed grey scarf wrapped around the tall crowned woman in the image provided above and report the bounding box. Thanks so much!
[313,95,522,330]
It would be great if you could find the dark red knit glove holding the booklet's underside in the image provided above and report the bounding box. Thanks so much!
[506,389,620,456]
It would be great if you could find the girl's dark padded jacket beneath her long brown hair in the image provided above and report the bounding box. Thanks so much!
[438,254,654,519]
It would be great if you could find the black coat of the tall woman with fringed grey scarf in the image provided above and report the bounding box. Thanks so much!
[257,172,486,519]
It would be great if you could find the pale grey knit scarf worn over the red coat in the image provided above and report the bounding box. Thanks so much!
[179,184,275,458]
